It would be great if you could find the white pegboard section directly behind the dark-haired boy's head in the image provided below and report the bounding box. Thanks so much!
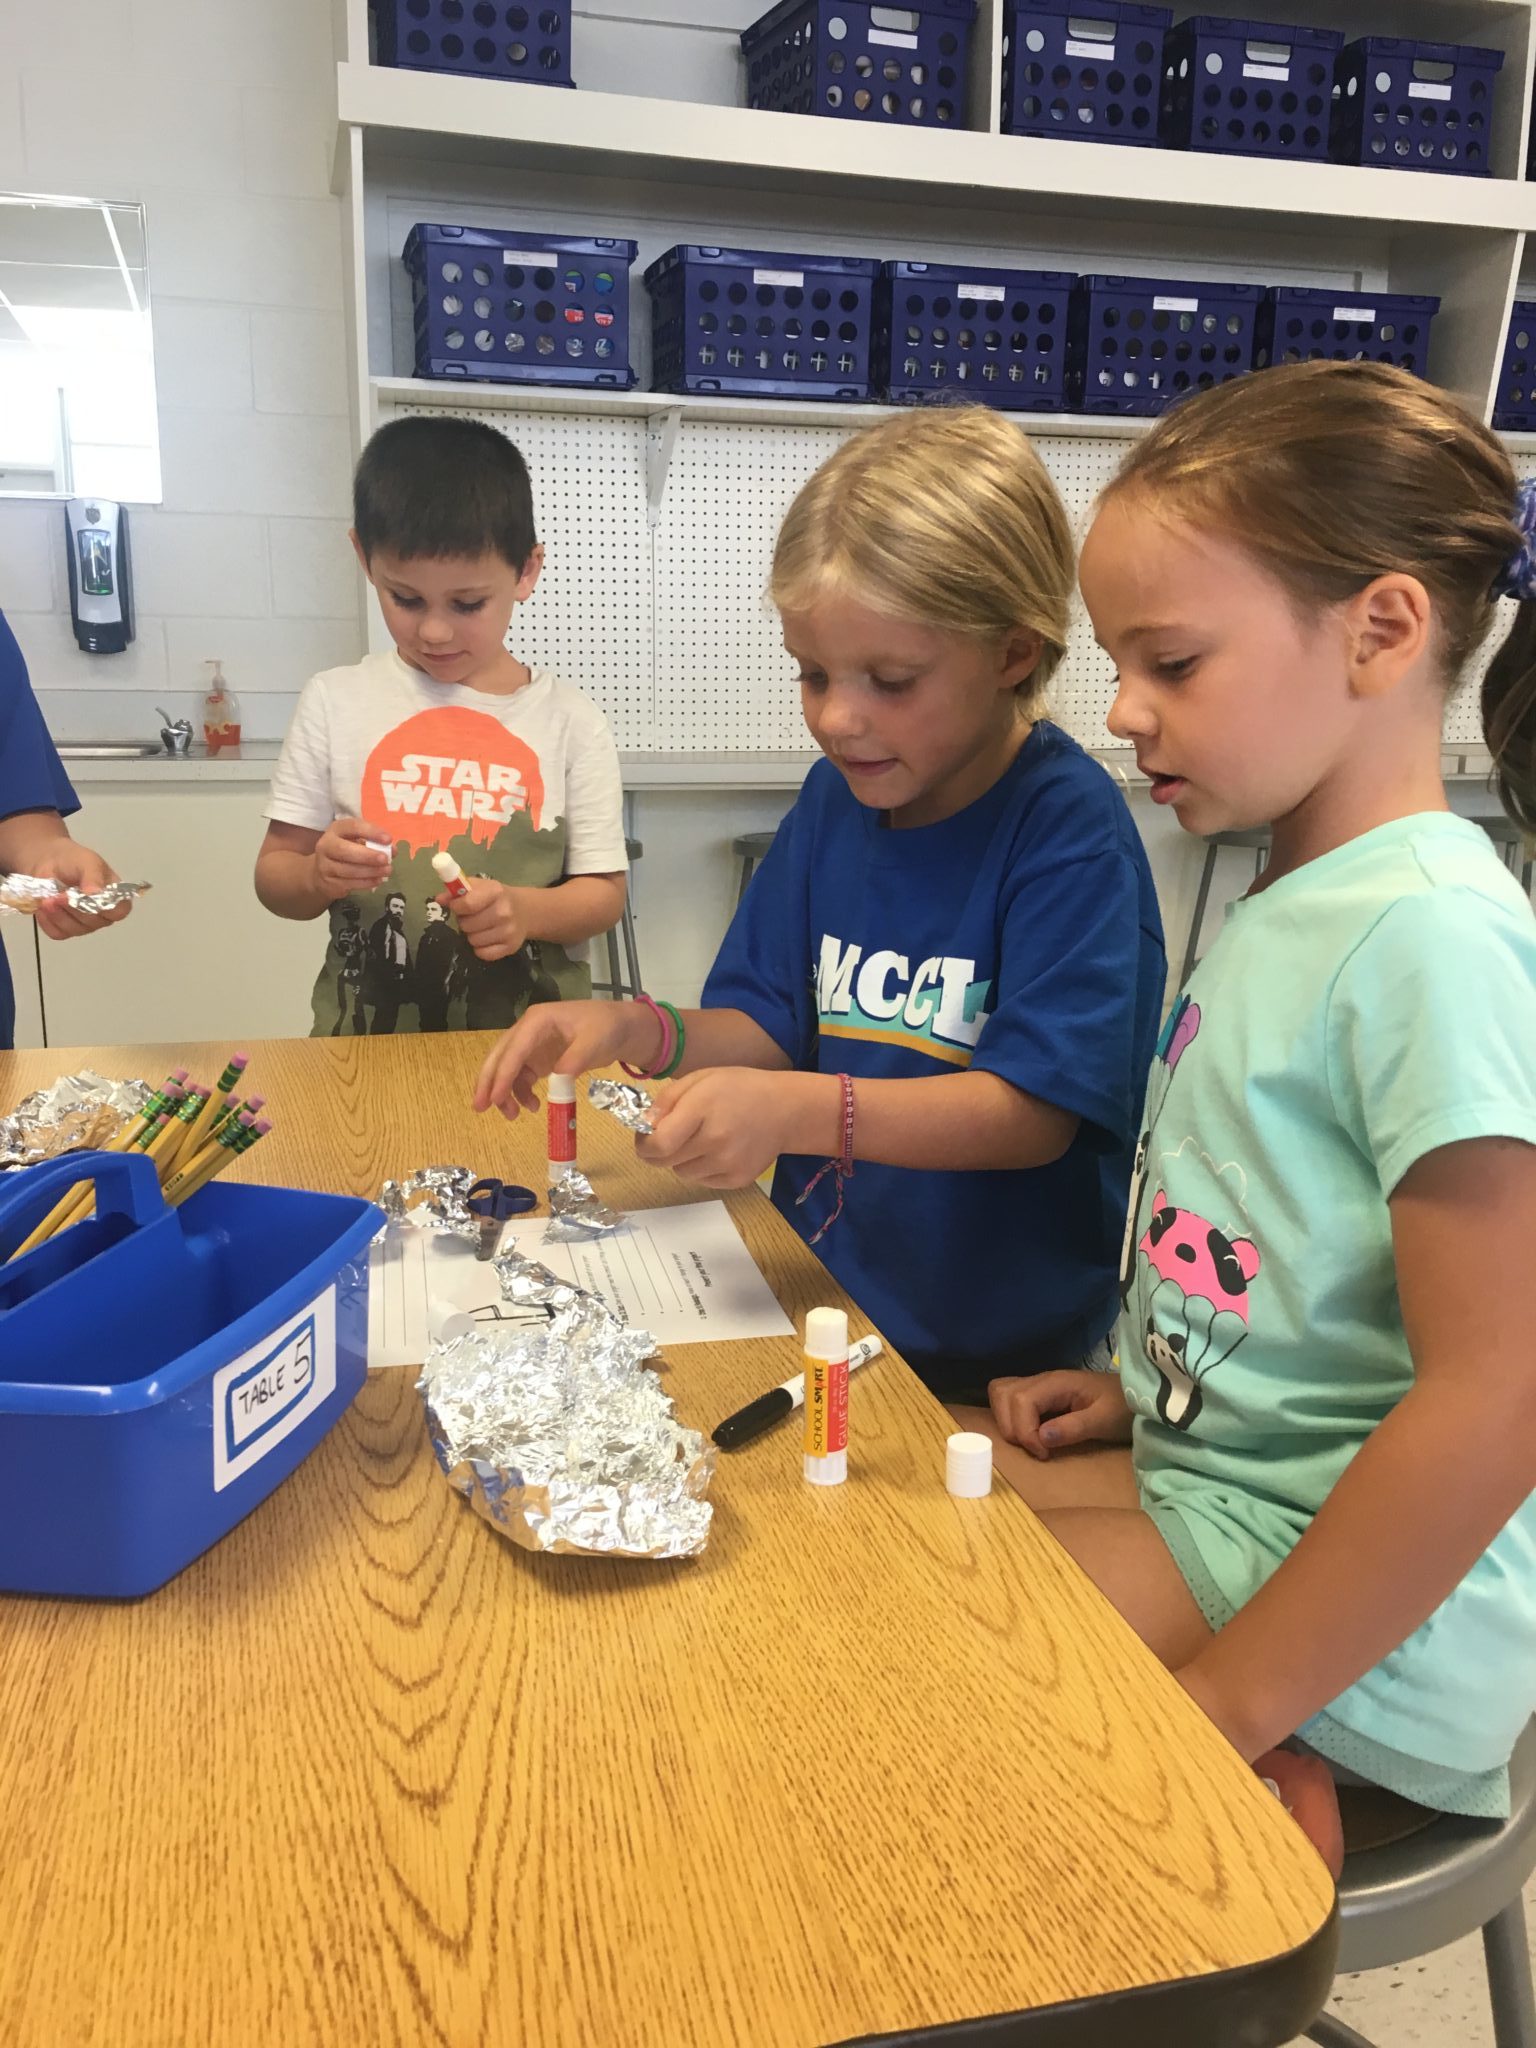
[383,403,657,754]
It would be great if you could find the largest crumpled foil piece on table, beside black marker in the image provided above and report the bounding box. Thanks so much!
[418,1253,715,1556]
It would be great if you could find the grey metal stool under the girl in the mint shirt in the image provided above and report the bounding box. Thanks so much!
[1307,1722,1536,2048]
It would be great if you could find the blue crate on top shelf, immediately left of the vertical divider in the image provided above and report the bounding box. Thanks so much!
[741,0,977,127]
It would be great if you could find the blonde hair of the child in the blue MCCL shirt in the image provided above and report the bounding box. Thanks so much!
[770,406,1073,717]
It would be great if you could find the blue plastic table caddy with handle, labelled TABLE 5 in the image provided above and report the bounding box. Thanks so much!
[0,1153,383,1597]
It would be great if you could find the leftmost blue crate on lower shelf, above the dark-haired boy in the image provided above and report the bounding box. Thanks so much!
[401,221,635,391]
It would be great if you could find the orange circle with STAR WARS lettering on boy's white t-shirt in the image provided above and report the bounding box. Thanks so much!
[362,709,545,852]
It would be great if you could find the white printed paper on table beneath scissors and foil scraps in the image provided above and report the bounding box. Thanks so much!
[369,1202,795,1368]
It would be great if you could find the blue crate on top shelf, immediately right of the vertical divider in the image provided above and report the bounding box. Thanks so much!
[1001,0,1174,147]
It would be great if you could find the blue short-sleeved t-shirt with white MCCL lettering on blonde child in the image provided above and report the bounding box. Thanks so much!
[705,725,1165,1401]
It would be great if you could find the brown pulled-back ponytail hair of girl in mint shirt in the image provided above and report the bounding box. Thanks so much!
[1104,362,1536,831]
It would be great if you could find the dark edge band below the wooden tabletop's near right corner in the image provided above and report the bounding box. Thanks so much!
[838,1894,1339,2048]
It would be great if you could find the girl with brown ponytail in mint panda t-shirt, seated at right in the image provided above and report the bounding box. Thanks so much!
[991,362,1536,1866]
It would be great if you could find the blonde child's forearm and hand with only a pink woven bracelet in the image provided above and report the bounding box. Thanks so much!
[639,1073,1077,1188]
